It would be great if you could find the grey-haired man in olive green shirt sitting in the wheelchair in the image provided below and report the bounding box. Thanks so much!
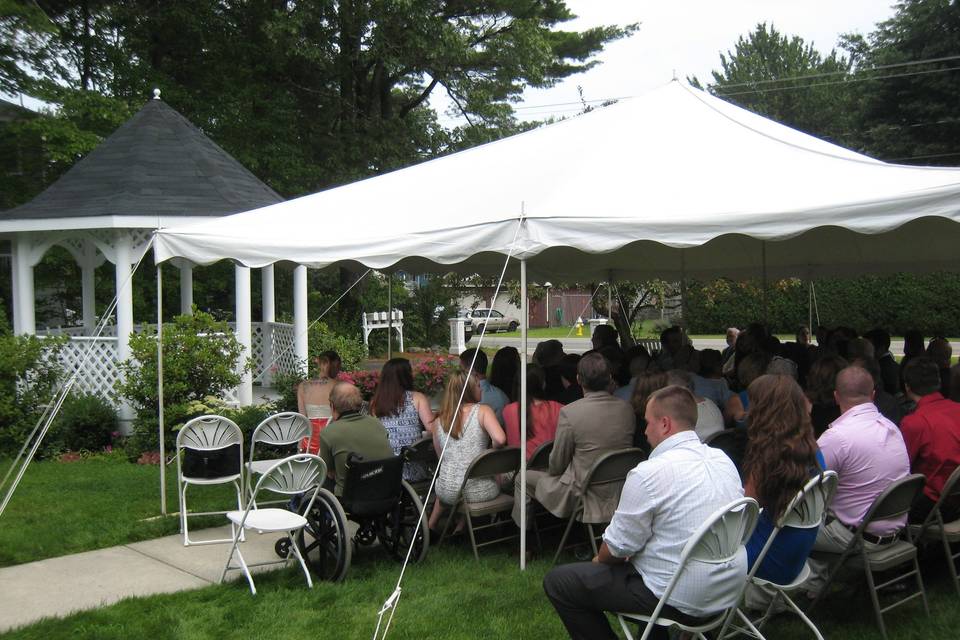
[320,382,393,496]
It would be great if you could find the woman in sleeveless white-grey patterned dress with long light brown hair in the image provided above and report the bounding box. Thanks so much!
[429,370,507,529]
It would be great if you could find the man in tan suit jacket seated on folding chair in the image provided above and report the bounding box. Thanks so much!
[513,353,636,523]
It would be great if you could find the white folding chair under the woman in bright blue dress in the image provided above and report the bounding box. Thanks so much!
[717,471,839,640]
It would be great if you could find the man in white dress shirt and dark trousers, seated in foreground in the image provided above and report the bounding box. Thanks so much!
[543,386,747,640]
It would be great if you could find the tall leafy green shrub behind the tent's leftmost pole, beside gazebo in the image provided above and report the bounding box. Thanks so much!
[117,311,251,457]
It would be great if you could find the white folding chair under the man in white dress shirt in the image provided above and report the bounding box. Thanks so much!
[616,498,760,640]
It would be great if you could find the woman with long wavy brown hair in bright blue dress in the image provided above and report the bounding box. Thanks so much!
[743,375,826,584]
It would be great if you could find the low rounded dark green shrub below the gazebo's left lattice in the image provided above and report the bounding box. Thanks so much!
[47,394,119,452]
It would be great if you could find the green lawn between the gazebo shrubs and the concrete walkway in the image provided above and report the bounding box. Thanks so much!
[0,457,236,566]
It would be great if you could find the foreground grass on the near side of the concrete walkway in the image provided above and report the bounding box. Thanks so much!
[0,545,960,640]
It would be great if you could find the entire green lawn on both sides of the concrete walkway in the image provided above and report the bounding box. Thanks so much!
[0,459,960,640]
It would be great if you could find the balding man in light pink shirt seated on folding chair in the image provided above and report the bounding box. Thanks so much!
[808,366,910,591]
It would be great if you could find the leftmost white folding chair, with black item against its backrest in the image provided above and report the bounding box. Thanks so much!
[177,415,243,547]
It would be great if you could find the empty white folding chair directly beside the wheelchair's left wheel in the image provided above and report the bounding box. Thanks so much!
[220,453,324,595]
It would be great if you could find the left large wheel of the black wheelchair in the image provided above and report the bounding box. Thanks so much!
[297,489,353,582]
